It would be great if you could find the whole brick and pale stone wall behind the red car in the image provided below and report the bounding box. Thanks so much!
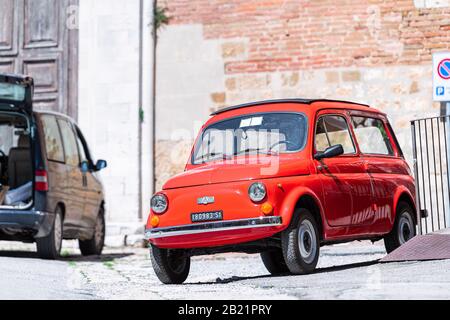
[157,0,450,187]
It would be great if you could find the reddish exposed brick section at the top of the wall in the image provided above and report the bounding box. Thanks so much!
[163,0,450,74]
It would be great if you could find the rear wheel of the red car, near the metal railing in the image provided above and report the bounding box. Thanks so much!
[384,202,417,254]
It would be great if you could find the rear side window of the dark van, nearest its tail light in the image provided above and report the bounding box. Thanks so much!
[41,115,64,162]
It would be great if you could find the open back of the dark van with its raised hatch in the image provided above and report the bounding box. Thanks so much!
[0,74,35,210]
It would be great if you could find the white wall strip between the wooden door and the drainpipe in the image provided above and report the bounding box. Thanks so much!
[79,0,142,234]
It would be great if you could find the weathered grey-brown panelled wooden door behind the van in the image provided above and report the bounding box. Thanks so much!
[0,0,78,118]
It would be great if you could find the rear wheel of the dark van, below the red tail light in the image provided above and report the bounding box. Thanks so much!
[36,206,63,260]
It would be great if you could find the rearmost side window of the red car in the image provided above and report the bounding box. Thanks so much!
[352,117,394,156]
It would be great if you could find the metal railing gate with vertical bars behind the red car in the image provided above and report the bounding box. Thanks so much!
[411,116,450,234]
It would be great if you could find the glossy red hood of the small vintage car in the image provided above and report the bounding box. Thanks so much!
[163,156,311,190]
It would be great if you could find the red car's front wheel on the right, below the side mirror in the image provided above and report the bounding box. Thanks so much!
[281,208,320,274]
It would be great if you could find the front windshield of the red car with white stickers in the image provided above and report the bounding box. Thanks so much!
[192,113,307,164]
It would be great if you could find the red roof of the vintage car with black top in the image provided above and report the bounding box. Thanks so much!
[211,98,372,116]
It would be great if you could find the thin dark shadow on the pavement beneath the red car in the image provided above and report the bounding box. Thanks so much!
[186,259,380,285]
